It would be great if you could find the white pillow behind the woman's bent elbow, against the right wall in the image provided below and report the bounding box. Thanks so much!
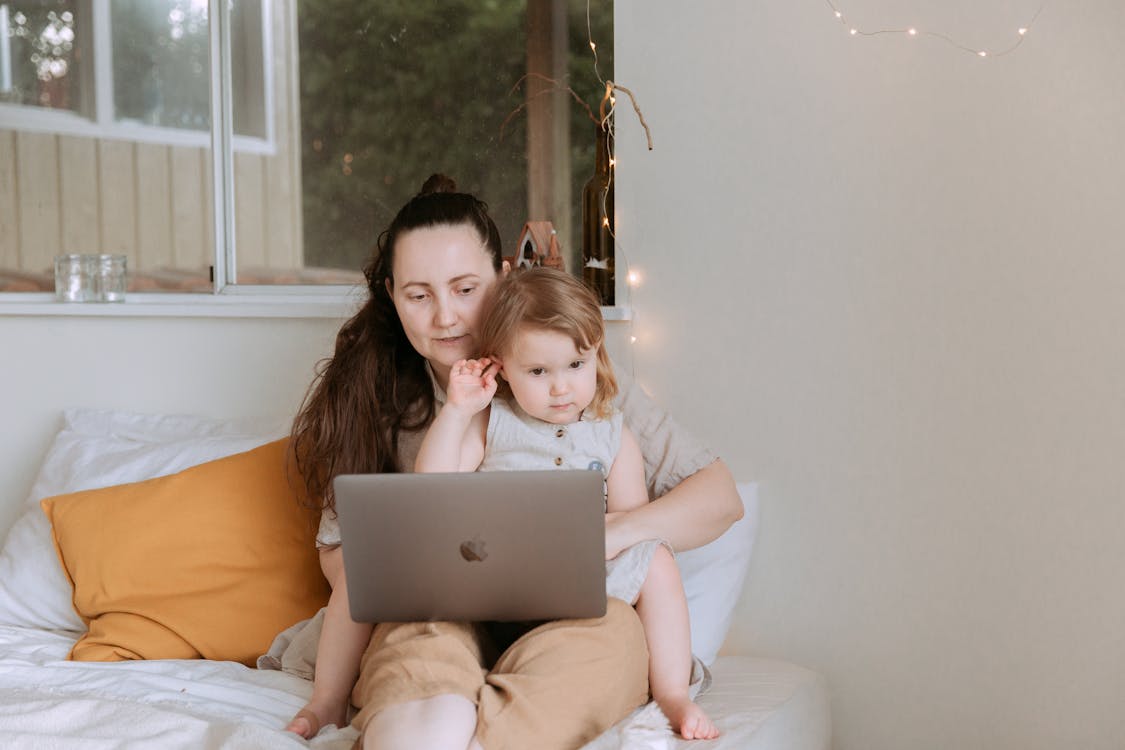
[676,482,758,665]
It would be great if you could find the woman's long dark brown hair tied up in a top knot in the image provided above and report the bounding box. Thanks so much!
[289,174,503,509]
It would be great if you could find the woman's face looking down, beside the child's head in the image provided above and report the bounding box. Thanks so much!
[387,225,498,387]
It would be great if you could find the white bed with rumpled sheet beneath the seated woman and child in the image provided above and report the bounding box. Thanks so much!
[0,626,829,750]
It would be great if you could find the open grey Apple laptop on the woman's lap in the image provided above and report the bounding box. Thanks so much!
[333,470,605,623]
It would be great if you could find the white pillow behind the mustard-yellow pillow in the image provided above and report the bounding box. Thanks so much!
[0,409,289,632]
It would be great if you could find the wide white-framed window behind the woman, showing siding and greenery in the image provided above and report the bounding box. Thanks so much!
[0,0,612,292]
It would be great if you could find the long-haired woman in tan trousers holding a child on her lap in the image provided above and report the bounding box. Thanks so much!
[290,175,741,750]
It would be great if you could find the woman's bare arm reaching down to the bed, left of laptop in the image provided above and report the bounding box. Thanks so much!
[286,546,372,739]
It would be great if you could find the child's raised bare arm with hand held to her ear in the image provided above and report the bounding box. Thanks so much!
[414,359,496,472]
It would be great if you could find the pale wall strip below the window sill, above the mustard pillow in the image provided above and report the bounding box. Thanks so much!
[0,316,340,534]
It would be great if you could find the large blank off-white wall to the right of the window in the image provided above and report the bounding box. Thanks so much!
[615,0,1125,750]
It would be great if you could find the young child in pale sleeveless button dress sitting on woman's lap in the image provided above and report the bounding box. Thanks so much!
[415,268,719,740]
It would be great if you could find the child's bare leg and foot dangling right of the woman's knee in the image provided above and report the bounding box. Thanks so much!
[637,545,719,740]
